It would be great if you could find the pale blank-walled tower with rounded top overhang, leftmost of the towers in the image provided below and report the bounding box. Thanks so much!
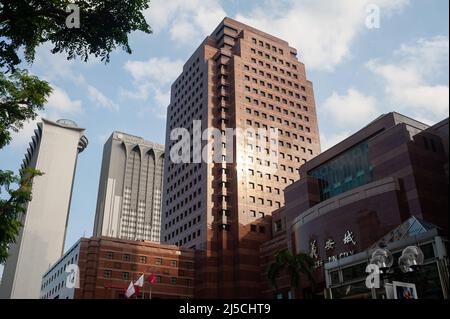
[0,119,88,299]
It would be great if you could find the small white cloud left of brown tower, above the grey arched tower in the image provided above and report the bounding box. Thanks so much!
[124,58,184,84]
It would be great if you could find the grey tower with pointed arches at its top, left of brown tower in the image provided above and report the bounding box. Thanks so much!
[93,132,164,242]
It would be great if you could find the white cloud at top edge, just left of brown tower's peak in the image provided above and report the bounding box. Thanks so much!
[145,0,226,44]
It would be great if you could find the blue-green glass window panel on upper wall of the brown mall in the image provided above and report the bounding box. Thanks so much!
[309,141,373,201]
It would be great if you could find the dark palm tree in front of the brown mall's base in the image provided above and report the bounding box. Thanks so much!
[267,249,314,299]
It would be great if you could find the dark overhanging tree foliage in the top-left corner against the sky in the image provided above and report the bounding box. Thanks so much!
[0,0,152,71]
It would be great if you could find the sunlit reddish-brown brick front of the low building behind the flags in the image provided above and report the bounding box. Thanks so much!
[75,237,195,299]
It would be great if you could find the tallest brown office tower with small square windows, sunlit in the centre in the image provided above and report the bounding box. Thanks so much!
[161,18,320,298]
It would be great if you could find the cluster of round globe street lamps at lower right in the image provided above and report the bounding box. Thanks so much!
[369,246,424,299]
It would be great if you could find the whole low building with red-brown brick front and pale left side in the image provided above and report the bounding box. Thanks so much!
[41,237,195,299]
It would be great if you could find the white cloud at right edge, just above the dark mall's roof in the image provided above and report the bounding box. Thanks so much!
[366,36,449,122]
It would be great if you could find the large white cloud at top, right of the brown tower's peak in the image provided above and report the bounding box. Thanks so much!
[237,0,409,71]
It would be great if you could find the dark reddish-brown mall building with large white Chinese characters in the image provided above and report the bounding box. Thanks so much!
[261,113,449,298]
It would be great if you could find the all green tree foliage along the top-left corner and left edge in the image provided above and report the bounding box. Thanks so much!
[0,0,151,263]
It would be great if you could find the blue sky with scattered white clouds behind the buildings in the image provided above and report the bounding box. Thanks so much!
[0,0,449,271]
